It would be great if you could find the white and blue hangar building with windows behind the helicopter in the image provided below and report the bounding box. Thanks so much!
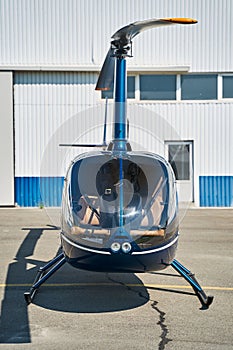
[0,0,233,207]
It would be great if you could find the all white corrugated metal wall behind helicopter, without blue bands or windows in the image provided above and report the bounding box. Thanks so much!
[0,0,233,204]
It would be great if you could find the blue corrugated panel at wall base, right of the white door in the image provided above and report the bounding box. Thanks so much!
[199,176,233,207]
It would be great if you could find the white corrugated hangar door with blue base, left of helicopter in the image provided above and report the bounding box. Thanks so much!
[14,72,97,206]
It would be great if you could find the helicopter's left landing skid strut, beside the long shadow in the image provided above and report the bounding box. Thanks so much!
[24,253,66,305]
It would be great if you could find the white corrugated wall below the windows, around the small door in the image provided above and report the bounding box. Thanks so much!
[129,102,233,204]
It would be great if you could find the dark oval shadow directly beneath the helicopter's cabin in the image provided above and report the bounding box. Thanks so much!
[33,264,149,313]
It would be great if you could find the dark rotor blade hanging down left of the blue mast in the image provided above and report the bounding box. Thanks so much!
[95,48,115,90]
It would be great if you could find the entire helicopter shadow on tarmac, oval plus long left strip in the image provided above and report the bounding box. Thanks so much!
[0,225,149,344]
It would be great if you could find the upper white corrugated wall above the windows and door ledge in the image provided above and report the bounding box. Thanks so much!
[0,0,233,72]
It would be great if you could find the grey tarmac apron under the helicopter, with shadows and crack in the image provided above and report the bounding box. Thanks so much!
[0,208,233,350]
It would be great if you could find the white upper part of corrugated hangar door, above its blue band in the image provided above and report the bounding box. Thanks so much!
[14,73,104,176]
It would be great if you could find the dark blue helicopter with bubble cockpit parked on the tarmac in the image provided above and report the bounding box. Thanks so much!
[24,18,213,309]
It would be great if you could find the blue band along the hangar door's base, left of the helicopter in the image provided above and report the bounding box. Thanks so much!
[15,177,64,207]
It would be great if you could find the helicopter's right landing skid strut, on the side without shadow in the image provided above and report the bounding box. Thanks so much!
[171,259,214,309]
